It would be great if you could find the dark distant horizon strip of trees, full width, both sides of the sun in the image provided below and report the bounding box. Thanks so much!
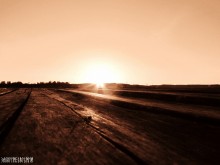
[0,81,220,94]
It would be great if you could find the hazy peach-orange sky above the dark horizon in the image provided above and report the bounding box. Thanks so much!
[0,0,220,84]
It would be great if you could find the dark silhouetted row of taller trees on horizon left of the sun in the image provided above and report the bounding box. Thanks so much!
[0,81,76,88]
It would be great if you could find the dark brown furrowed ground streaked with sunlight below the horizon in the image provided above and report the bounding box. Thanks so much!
[0,88,220,165]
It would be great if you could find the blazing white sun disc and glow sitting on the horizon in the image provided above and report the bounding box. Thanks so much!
[83,63,118,88]
